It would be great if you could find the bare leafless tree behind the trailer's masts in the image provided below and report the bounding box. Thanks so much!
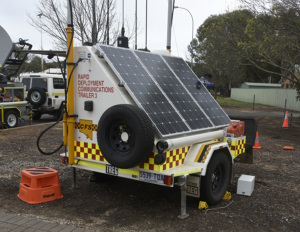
[29,0,125,49]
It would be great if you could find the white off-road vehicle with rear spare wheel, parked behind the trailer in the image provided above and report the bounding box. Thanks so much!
[20,73,65,119]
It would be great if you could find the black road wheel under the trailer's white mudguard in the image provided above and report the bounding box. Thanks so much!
[200,151,230,205]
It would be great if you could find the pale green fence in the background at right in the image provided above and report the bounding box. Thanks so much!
[231,88,300,111]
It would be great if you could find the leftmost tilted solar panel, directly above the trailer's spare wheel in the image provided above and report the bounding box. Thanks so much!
[99,45,190,137]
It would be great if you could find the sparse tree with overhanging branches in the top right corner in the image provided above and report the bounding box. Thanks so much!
[239,0,300,90]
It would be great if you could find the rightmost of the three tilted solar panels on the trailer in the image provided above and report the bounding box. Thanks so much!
[163,56,230,127]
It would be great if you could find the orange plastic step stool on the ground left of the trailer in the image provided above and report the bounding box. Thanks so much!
[18,167,63,204]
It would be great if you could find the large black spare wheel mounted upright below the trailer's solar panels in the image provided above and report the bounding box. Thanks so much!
[97,105,154,168]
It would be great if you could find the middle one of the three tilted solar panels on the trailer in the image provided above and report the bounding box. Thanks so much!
[134,51,213,130]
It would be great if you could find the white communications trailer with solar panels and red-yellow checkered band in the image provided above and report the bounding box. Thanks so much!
[61,36,252,218]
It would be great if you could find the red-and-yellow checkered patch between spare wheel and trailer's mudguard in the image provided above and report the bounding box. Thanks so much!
[139,147,190,171]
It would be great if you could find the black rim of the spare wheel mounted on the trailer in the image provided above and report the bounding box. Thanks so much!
[108,123,133,153]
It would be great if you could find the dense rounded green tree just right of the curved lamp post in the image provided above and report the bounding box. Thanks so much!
[188,10,276,96]
